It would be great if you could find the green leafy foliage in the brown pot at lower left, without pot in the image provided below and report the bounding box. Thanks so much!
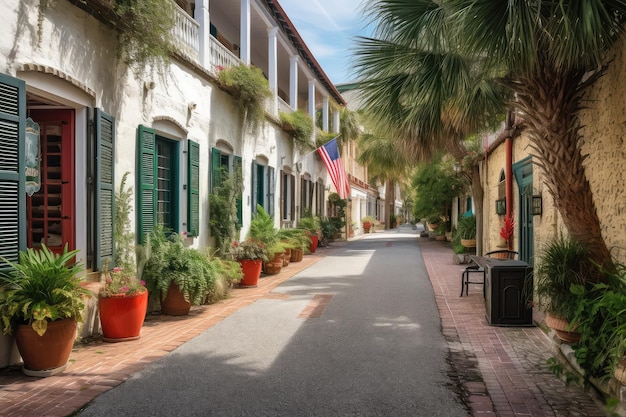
[0,244,91,336]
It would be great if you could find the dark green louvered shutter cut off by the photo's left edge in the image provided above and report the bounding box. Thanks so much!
[0,74,26,262]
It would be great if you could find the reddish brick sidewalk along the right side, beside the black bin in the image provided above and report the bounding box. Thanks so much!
[418,239,607,417]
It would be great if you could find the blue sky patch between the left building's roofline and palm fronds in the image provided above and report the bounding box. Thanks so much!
[279,0,367,84]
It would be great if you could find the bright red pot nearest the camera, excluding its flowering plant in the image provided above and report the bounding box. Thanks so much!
[98,291,148,342]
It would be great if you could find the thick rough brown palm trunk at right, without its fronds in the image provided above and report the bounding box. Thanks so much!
[511,65,610,263]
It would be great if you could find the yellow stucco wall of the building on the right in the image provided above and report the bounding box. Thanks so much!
[482,35,626,263]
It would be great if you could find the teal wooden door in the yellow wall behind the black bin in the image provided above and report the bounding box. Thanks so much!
[513,157,535,265]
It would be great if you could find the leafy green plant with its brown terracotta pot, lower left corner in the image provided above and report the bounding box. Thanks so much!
[0,244,91,376]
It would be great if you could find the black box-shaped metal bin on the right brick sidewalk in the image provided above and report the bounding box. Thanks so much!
[485,258,533,326]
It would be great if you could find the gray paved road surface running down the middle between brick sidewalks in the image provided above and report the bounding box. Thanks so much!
[79,228,469,417]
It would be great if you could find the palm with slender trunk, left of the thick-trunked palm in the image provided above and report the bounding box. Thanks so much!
[356,0,507,253]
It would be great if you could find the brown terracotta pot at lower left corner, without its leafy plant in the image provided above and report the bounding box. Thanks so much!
[15,319,76,376]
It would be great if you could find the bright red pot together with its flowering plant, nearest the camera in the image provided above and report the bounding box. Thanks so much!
[98,267,148,342]
